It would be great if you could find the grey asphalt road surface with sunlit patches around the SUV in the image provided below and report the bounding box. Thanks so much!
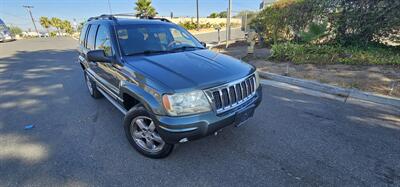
[0,38,400,186]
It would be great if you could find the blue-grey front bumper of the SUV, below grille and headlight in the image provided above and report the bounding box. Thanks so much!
[155,86,262,144]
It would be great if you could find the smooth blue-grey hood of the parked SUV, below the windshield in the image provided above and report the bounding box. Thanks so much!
[126,50,254,91]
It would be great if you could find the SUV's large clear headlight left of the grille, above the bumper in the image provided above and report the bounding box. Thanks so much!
[162,90,211,116]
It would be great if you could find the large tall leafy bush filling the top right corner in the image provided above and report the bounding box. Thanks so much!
[251,0,400,46]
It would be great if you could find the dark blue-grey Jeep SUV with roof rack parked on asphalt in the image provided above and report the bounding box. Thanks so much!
[79,15,262,158]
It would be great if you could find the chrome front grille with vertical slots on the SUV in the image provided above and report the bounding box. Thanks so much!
[205,75,256,113]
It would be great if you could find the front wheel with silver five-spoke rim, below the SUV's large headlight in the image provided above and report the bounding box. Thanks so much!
[124,105,174,158]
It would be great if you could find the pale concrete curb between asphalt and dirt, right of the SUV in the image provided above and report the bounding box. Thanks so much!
[258,71,400,107]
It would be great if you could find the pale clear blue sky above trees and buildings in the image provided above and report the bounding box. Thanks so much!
[0,0,261,30]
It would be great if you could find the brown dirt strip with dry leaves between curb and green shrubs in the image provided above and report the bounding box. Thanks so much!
[214,45,400,97]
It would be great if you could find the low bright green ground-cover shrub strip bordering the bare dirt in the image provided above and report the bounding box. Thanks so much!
[270,43,400,65]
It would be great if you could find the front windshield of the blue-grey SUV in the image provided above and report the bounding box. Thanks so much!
[117,24,204,56]
